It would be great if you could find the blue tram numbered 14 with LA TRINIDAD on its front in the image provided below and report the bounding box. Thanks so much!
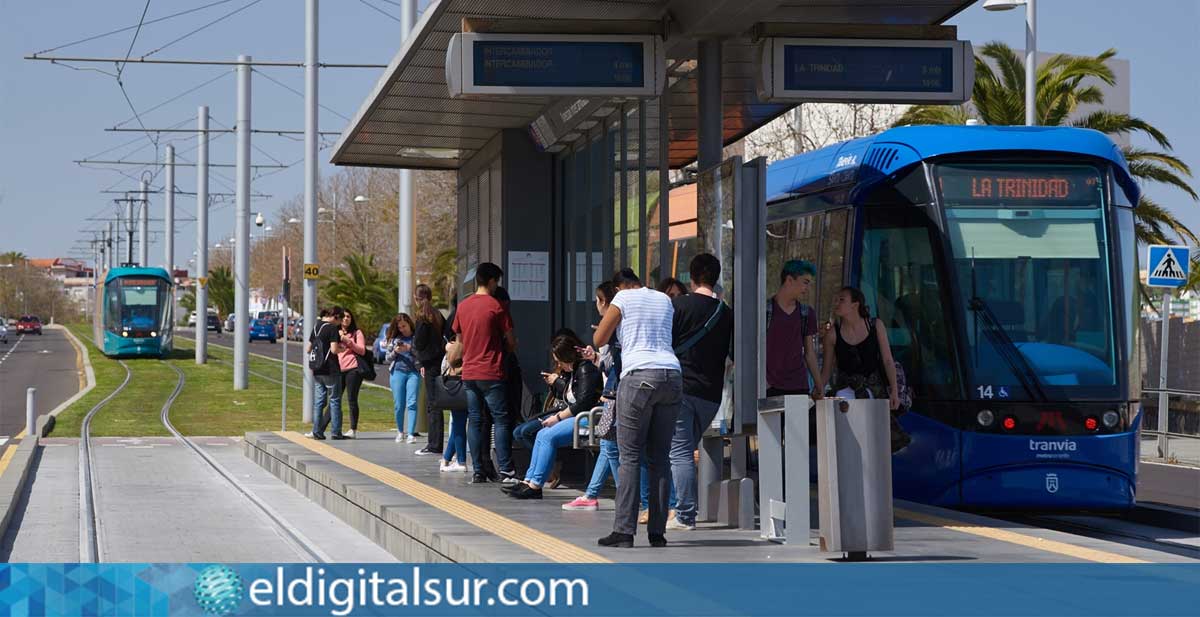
[766,126,1141,510]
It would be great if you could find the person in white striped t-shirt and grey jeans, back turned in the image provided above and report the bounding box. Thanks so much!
[593,268,683,547]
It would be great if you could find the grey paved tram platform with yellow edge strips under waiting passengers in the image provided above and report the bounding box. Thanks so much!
[244,432,1190,563]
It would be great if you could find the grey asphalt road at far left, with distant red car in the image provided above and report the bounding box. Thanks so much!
[0,328,80,437]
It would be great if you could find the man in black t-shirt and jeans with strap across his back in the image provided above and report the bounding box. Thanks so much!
[666,253,733,531]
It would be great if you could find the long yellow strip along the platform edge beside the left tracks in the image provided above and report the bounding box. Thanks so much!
[275,431,612,563]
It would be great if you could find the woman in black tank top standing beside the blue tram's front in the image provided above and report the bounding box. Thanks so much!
[821,287,900,411]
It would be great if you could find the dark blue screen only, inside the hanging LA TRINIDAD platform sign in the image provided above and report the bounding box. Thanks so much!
[784,44,954,92]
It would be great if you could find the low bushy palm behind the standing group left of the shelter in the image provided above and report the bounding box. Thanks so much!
[322,254,396,334]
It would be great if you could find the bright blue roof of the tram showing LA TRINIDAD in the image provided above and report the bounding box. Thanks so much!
[767,126,1140,203]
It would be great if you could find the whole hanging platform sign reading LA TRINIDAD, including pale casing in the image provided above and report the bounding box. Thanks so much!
[758,37,974,104]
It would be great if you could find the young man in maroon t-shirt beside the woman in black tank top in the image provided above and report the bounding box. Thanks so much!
[767,259,824,399]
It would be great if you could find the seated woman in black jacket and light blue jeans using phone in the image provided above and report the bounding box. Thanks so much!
[509,336,602,499]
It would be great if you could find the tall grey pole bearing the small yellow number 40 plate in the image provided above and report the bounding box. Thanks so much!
[300,0,318,423]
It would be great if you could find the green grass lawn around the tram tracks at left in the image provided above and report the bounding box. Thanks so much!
[53,325,395,437]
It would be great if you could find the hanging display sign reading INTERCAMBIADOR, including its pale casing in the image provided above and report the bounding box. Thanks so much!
[446,32,666,96]
